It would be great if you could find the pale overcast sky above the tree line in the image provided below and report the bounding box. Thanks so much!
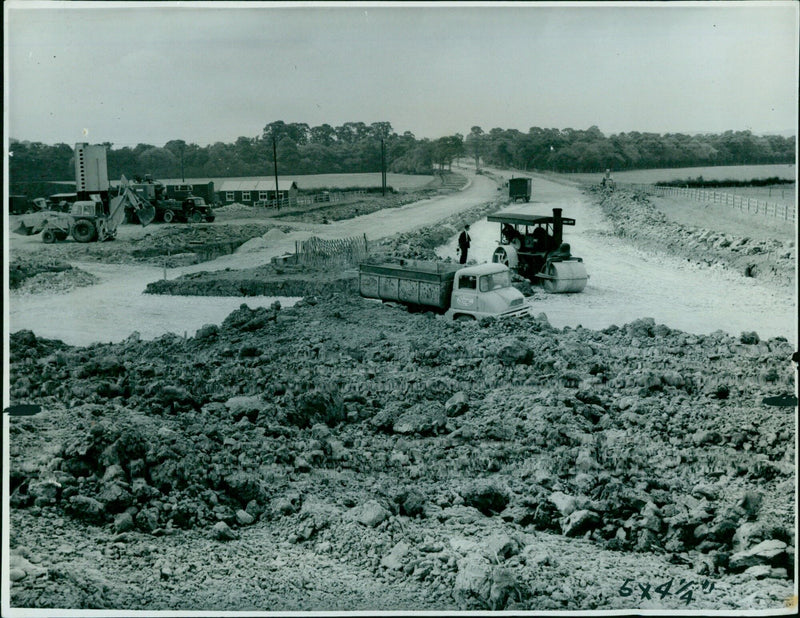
[4,0,800,147]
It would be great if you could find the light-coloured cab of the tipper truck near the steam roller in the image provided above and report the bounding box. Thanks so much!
[445,263,530,320]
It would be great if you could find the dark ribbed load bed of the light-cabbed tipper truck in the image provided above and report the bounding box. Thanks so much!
[359,262,460,310]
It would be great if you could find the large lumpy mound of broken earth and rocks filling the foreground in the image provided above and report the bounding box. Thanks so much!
[10,295,796,609]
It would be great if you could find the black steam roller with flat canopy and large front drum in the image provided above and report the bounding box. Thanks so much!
[486,208,589,294]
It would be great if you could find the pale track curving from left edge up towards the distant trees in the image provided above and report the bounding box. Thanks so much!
[9,176,497,345]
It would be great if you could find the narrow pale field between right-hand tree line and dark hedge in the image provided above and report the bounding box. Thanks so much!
[561,164,797,184]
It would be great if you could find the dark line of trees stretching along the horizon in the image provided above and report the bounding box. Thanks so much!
[9,121,796,185]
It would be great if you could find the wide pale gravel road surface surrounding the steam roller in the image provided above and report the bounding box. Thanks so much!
[438,171,797,342]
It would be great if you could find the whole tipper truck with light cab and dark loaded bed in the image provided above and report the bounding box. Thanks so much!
[359,262,531,320]
